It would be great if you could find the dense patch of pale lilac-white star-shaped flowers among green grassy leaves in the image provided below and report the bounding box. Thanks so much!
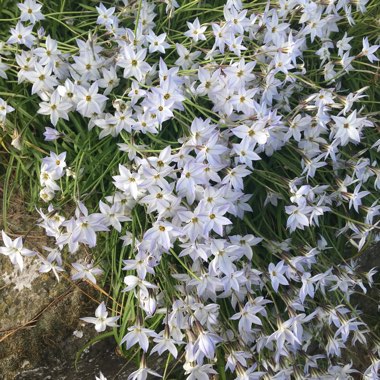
[0,0,380,380]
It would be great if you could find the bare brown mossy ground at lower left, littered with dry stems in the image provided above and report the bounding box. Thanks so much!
[0,192,144,380]
